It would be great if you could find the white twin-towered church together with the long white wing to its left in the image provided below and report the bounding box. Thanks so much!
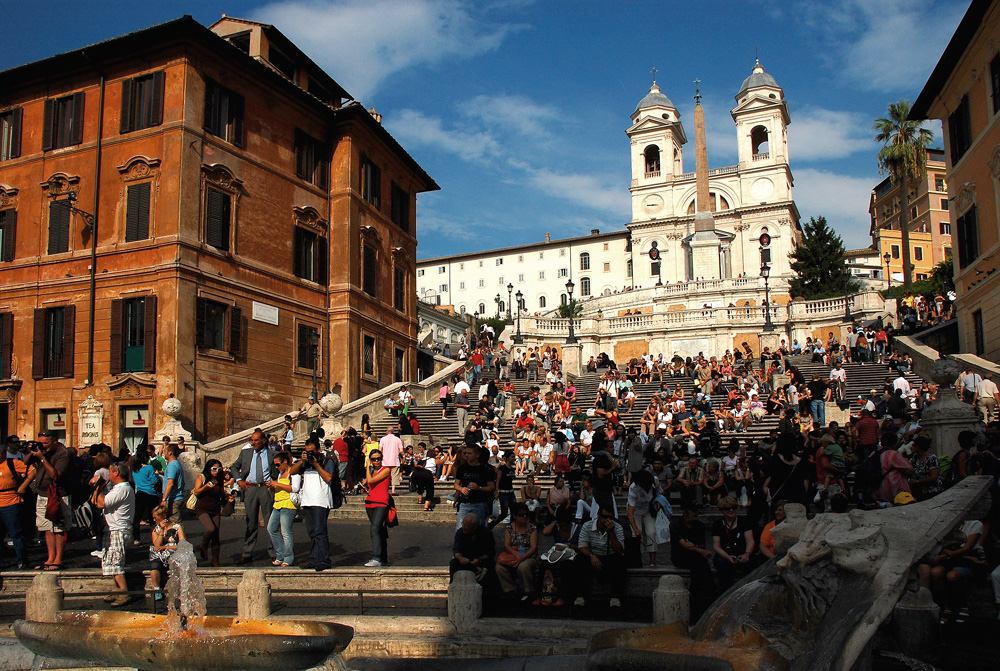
[417,62,801,314]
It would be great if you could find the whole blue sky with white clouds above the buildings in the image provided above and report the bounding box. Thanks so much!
[0,0,968,258]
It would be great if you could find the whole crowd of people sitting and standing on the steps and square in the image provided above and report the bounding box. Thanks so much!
[0,320,1000,620]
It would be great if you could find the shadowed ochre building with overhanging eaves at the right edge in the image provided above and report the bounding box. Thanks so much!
[910,0,1000,361]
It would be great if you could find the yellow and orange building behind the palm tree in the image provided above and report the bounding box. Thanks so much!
[868,149,952,283]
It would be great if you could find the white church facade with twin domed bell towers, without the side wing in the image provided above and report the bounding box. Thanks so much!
[626,62,801,292]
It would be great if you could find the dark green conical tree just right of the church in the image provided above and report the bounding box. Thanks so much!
[790,217,858,300]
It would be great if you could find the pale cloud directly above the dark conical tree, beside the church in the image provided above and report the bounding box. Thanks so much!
[795,168,879,249]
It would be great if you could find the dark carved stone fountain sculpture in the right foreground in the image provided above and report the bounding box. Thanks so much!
[349,476,992,671]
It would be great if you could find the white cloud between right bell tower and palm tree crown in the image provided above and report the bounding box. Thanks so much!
[788,107,878,161]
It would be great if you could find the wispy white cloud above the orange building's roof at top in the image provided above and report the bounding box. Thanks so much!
[253,0,517,100]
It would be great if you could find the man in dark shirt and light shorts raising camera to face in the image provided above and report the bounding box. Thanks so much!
[28,430,73,571]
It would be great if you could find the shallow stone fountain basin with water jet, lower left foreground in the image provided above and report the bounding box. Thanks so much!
[14,611,354,671]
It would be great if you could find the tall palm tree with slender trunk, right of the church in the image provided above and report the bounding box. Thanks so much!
[875,100,934,288]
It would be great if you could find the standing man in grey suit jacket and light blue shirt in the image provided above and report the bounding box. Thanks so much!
[232,429,277,564]
